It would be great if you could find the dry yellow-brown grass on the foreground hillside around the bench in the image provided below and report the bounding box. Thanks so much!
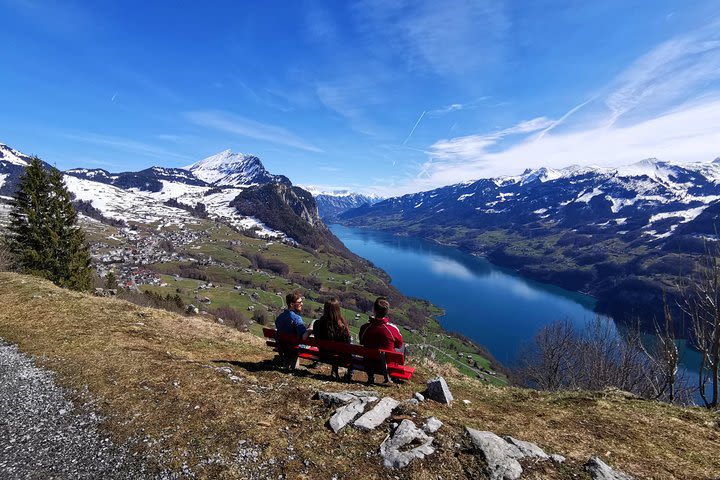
[0,273,720,480]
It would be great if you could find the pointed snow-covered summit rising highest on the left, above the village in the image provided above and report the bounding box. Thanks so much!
[184,150,290,187]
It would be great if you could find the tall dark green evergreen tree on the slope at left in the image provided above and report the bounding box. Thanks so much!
[8,157,92,290]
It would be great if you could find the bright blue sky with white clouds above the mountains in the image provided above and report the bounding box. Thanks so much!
[0,0,720,195]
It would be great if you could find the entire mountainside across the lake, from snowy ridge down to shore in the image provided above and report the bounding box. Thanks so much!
[340,159,720,332]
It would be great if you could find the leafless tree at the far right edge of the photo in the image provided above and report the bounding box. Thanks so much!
[682,248,720,409]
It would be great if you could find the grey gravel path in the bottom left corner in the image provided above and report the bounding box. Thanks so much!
[0,339,151,480]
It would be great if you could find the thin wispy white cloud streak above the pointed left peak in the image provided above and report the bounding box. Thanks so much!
[184,111,323,152]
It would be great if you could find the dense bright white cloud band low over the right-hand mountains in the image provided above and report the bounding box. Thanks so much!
[410,98,720,192]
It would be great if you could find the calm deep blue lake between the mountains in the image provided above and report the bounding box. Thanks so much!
[330,225,608,365]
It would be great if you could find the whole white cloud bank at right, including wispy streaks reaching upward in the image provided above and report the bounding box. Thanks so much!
[392,18,720,194]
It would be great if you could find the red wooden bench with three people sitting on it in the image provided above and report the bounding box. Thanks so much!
[263,328,415,382]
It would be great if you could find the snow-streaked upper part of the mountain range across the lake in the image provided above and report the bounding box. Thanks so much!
[343,159,720,238]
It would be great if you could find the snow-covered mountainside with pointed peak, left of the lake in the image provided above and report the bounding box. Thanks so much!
[0,144,334,240]
